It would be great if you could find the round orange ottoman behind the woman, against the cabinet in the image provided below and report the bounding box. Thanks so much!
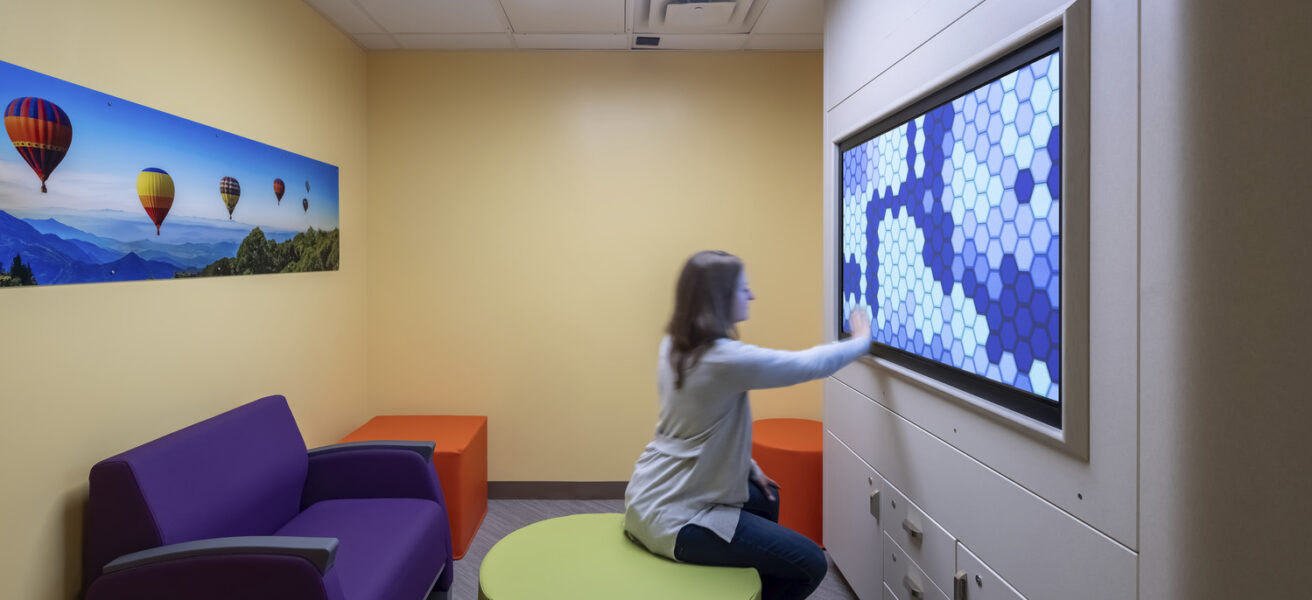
[752,419,824,546]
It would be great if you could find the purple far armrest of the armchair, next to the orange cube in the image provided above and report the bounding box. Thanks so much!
[300,441,446,509]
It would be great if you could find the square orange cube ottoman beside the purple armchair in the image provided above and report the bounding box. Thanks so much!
[341,415,488,558]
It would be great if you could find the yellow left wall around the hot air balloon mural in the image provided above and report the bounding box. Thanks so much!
[0,0,367,600]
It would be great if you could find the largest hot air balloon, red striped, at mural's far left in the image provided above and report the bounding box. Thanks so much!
[4,97,73,193]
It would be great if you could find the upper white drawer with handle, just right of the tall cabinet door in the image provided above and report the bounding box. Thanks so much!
[879,486,956,589]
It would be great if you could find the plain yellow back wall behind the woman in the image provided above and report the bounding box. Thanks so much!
[369,53,823,481]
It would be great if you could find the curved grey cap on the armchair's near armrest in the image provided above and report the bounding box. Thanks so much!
[104,536,337,575]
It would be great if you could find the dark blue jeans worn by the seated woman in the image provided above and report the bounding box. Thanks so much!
[674,482,829,600]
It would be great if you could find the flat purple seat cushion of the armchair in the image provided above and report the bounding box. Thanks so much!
[274,498,450,600]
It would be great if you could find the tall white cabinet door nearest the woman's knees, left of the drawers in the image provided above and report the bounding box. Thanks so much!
[824,431,884,600]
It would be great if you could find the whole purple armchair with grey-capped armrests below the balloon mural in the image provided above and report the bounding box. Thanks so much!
[83,395,453,600]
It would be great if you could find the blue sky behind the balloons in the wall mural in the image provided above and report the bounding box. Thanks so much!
[0,62,338,237]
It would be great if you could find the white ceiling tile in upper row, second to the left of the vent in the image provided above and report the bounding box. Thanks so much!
[357,0,506,33]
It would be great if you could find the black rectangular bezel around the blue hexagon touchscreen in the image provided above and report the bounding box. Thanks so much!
[834,28,1068,429]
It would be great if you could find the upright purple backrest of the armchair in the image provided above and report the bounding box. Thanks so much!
[85,395,308,580]
